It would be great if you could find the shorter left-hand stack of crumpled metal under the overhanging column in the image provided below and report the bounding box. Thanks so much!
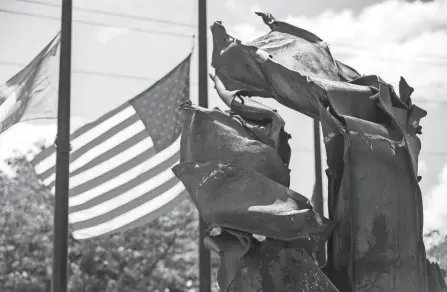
[173,96,337,292]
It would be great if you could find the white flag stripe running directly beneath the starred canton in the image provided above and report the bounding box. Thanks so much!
[70,140,180,206]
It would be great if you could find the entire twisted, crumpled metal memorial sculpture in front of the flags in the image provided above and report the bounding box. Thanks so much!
[173,13,447,292]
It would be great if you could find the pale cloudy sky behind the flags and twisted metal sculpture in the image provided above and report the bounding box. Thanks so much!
[0,0,447,244]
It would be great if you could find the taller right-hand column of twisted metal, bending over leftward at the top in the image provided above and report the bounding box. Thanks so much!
[207,13,447,292]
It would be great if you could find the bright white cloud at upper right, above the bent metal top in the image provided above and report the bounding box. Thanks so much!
[229,1,447,100]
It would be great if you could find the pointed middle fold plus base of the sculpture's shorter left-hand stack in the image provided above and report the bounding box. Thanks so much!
[173,160,338,292]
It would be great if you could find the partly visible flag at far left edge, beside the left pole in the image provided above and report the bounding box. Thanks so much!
[0,34,60,134]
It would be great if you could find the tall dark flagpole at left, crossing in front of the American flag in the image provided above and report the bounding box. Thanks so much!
[51,0,73,292]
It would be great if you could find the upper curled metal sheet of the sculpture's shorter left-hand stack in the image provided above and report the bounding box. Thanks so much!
[180,104,290,186]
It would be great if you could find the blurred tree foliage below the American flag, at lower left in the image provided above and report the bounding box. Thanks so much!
[0,158,217,292]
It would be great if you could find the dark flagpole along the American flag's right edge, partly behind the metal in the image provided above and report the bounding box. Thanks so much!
[198,0,211,292]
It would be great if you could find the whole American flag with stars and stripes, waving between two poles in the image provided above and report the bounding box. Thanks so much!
[32,55,191,239]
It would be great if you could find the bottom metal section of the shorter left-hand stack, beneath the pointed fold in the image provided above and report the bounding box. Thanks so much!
[219,239,338,292]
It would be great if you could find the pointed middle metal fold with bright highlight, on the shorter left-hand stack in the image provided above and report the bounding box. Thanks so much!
[173,161,328,247]
